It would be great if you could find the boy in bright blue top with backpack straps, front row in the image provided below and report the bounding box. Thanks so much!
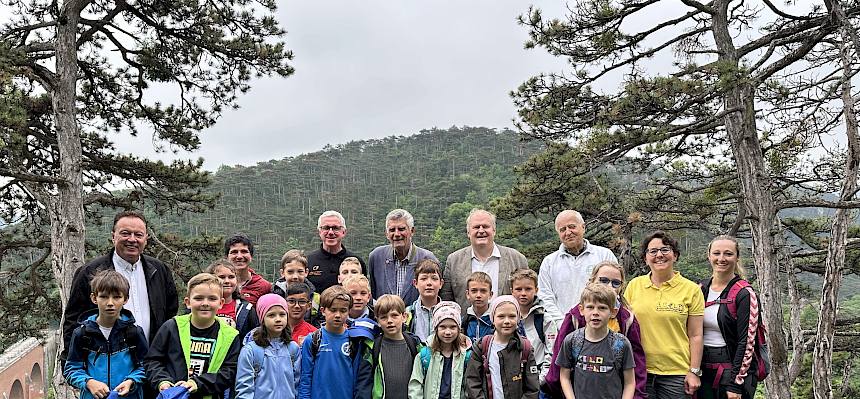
[298,285,372,399]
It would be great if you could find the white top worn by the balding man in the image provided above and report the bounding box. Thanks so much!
[537,240,618,320]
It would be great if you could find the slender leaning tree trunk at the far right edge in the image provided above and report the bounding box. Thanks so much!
[812,27,860,399]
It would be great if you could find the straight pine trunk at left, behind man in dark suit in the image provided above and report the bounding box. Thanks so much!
[47,0,87,397]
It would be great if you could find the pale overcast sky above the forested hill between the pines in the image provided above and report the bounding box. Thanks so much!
[116,0,565,170]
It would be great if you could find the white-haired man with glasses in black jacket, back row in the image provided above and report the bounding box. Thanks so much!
[307,211,367,293]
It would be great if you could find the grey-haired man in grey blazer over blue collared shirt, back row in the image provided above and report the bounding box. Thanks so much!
[367,209,438,304]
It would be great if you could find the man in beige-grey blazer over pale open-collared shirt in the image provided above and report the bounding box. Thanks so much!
[439,209,528,312]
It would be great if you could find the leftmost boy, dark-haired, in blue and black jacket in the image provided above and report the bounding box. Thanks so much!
[63,269,147,399]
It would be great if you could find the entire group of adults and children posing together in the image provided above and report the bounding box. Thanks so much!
[58,209,763,399]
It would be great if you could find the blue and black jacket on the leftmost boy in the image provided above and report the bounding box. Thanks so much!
[63,309,148,399]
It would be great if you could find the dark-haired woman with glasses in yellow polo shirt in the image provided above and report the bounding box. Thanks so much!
[624,231,705,399]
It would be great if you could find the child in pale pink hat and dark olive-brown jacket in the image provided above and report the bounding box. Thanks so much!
[466,295,540,399]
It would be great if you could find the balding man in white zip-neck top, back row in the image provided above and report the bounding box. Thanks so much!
[537,209,618,320]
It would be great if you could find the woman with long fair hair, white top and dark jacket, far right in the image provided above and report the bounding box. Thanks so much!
[699,236,759,399]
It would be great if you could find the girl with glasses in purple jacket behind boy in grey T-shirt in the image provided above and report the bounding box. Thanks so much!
[544,261,647,399]
